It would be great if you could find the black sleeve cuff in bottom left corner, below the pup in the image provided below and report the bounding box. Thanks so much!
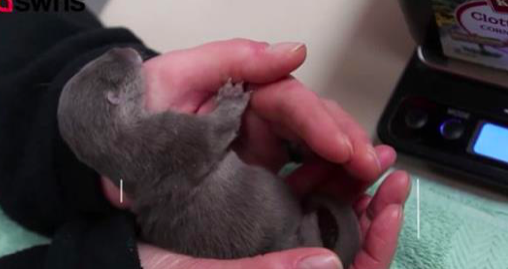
[0,214,141,269]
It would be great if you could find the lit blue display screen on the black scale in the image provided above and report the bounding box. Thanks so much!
[473,123,508,164]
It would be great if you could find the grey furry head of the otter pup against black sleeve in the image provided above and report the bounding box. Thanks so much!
[58,48,144,178]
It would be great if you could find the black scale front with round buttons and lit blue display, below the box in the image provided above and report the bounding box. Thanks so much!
[378,47,508,188]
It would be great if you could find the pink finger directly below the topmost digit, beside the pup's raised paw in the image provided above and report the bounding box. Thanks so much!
[251,78,353,163]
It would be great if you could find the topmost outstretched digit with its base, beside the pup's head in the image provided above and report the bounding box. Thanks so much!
[143,39,307,112]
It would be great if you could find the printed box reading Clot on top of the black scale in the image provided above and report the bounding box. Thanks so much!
[432,0,508,70]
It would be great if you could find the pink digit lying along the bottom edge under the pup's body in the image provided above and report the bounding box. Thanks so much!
[139,244,343,269]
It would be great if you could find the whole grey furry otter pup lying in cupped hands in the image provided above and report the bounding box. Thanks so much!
[58,48,360,266]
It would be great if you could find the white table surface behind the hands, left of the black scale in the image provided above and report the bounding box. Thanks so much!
[101,0,508,199]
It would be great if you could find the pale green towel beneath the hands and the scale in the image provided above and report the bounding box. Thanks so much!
[0,169,508,269]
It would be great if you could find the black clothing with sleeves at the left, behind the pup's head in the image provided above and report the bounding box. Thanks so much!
[0,9,156,269]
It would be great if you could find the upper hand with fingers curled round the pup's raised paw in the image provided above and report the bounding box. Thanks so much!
[144,39,395,188]
